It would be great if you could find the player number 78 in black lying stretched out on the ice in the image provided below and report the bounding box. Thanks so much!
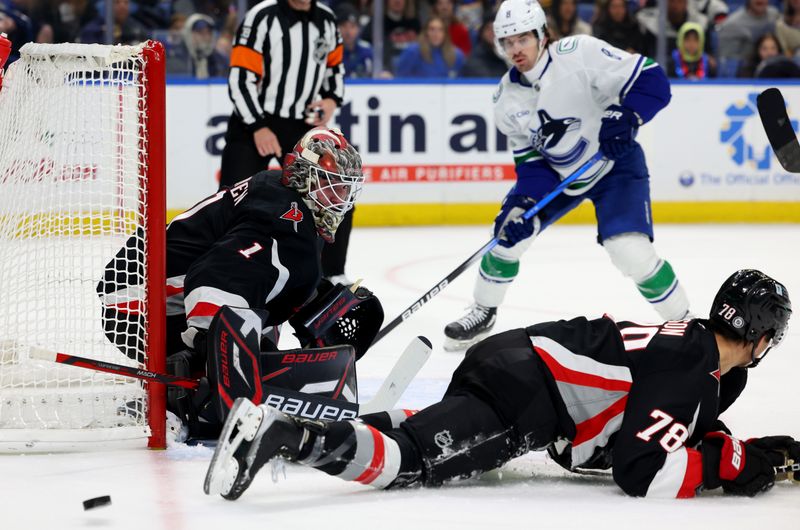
[204,270,800,499]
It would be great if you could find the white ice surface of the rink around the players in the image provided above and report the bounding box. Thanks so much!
[0,225,800,530]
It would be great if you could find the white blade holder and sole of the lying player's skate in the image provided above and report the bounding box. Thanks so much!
[203,398,263,496]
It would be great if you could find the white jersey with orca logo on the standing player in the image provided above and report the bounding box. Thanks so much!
[494,35,658,195]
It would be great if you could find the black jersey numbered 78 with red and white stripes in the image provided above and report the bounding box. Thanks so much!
[526,318,720,498]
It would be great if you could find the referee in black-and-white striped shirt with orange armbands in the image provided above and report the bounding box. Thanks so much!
[220,0,344,186]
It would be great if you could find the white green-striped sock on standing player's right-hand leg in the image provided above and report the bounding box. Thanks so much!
[603,232,689,320]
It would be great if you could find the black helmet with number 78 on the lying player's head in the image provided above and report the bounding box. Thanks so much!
[709,269,792,366]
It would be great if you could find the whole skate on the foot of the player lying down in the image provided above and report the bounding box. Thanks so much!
[203,398,303,500]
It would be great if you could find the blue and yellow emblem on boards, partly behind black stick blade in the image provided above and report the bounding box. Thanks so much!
[719,92,797,170]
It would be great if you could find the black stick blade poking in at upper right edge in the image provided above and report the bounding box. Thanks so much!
[756,88,800,173]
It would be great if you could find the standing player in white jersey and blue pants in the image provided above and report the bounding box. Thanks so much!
[445,0,689,350]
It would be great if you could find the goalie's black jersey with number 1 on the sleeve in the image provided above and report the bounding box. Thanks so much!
[97,171,322,353]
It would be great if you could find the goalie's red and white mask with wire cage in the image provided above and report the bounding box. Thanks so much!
[283,127,364,243]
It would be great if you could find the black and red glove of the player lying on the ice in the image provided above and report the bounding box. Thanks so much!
[700,432,777,497]
